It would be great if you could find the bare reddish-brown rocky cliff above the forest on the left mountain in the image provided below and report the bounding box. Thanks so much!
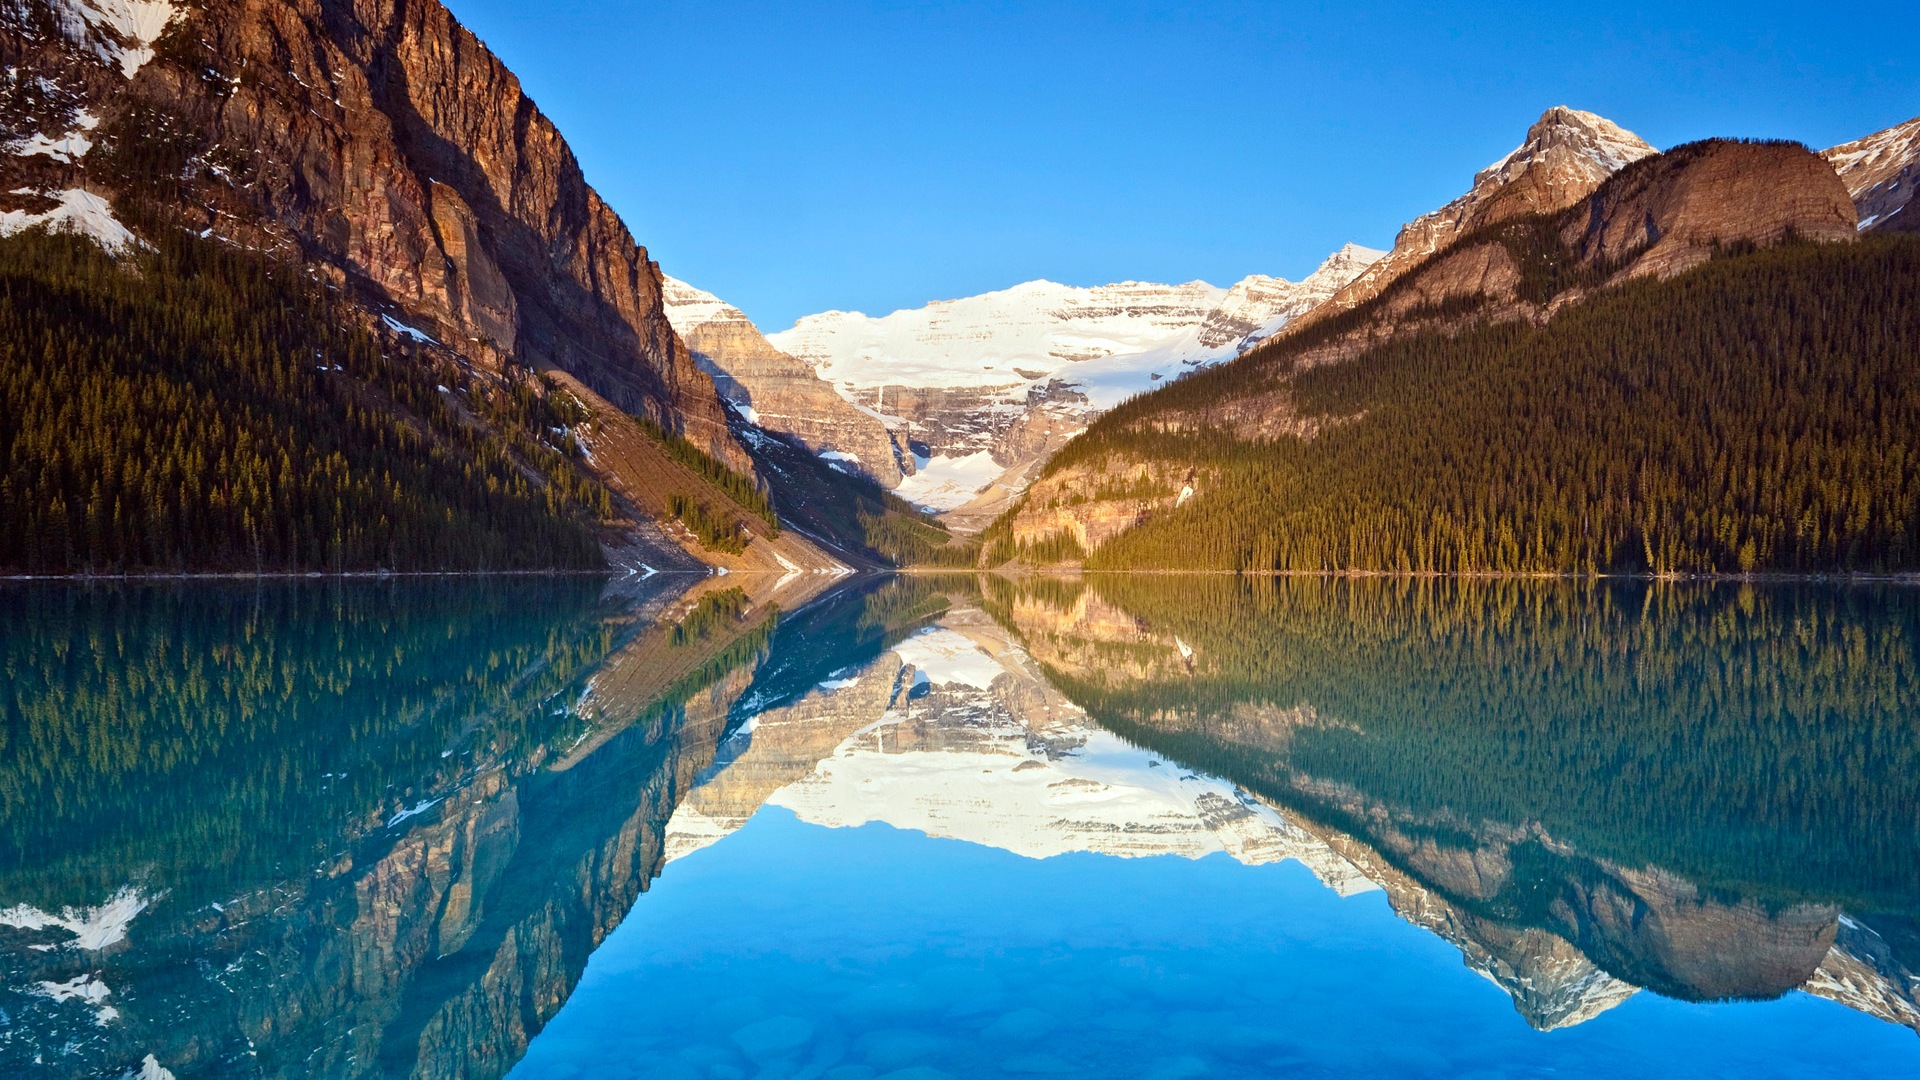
[0,0,751,467]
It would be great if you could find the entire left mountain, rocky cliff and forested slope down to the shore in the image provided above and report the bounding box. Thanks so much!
[0,0,933,571]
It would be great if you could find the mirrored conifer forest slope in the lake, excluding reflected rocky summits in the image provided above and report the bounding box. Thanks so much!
[985,575,1920,915]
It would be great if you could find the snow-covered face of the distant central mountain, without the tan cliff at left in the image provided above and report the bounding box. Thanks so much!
[741,244,1380,511]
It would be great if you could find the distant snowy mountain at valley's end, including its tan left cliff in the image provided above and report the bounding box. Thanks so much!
[668,244,1379,528]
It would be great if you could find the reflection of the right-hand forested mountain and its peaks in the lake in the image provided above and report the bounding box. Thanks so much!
[975,580,1920,1030]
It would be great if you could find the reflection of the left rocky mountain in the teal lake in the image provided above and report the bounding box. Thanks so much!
[0,578,875,1078]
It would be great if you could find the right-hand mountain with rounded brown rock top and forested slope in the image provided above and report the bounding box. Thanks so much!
[989,131,1920,573]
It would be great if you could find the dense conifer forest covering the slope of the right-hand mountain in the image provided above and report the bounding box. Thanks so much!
[1048,229,1920,573]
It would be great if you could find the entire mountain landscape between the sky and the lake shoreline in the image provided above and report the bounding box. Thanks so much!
[0,0,1920,580]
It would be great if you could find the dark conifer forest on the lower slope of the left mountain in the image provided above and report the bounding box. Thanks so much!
[0,227,611,573]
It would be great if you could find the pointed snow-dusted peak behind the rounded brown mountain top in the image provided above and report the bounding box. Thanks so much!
[1298,106,1655,327]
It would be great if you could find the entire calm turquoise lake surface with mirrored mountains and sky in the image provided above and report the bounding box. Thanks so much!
[0,575,1920,1080]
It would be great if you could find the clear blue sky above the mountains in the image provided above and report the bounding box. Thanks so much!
[449,0,1920,331]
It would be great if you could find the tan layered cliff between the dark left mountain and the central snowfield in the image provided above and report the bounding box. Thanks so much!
[664,277,914,480]
